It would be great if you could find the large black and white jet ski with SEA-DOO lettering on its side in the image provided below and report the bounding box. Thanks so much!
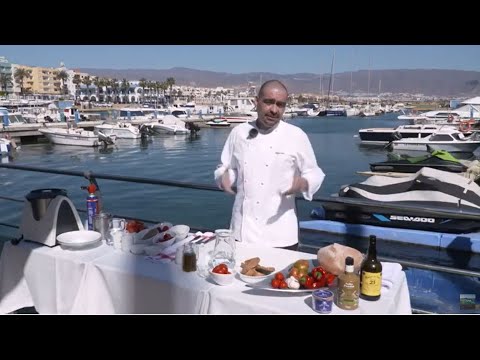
[313,167,480,234]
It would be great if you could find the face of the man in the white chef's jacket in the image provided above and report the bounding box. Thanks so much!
[256,84,288,129]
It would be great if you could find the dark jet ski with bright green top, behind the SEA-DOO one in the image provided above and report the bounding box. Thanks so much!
[370,150,467,173]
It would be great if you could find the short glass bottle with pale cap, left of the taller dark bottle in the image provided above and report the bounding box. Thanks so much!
[337,256,360,310]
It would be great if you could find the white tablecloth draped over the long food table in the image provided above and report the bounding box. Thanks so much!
[0,242,411,314]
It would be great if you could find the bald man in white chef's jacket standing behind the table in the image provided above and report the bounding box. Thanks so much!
[214,80,325,249]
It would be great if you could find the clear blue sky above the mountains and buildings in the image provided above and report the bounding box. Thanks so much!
[0,45,480,74]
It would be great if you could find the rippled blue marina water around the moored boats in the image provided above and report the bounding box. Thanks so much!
[0,113,480,312]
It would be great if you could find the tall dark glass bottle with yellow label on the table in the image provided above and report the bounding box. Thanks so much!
[360,235,382,301]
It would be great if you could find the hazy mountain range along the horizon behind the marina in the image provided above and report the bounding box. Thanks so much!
[78,67,480,97]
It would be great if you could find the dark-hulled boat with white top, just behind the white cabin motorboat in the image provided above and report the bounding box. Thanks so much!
[358,124,464,145]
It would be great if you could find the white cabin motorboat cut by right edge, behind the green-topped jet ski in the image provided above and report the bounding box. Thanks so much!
[389,127,480,153]
